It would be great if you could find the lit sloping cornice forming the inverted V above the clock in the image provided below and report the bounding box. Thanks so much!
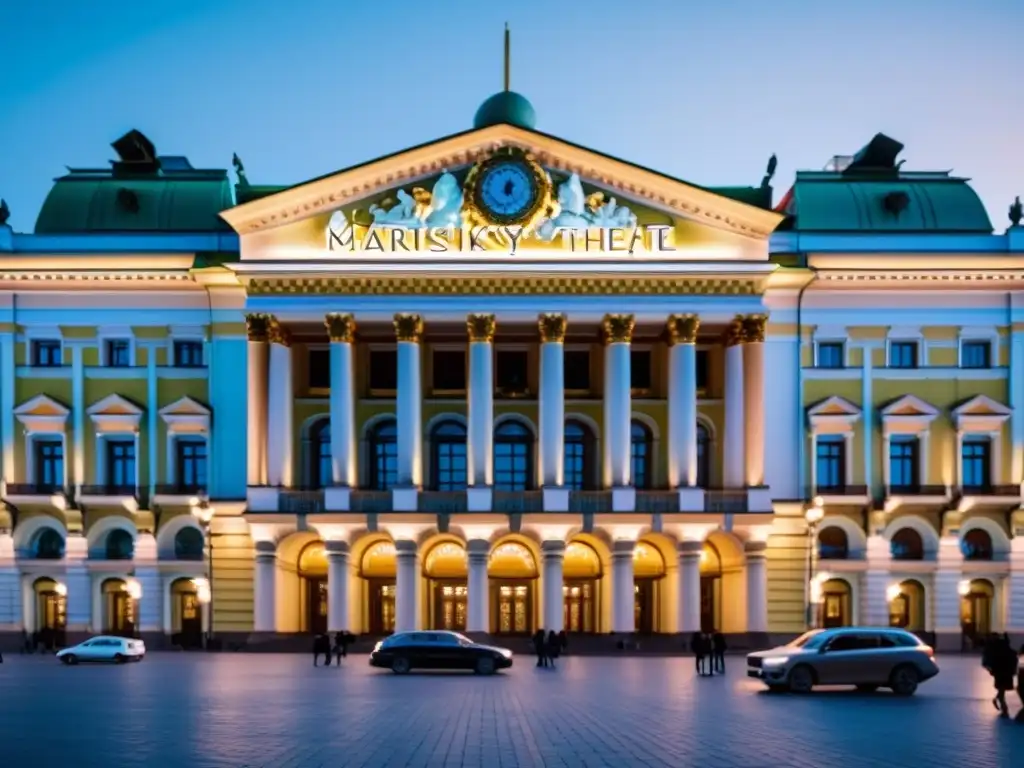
[220,125,783,240]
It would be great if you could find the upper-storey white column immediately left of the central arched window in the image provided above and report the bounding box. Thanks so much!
[466,314,496,487]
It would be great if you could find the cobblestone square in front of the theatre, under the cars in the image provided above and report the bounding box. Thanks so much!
[0,654,1024,768]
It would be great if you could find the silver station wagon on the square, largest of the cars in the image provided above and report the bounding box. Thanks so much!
[746,627,939,696]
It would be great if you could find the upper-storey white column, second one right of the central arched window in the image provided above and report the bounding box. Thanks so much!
[601,314,636,488]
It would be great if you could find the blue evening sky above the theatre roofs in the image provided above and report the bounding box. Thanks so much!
[0,0,1024,231]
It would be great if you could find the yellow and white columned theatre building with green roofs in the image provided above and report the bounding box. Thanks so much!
[0,91,1024,647]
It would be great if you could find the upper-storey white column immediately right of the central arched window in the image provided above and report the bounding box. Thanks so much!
[537,314,566,487]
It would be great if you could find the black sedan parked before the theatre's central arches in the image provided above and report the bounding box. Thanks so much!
[370,631,512,675]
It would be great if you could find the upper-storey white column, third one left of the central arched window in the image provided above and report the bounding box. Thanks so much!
[325,313,357,488]
